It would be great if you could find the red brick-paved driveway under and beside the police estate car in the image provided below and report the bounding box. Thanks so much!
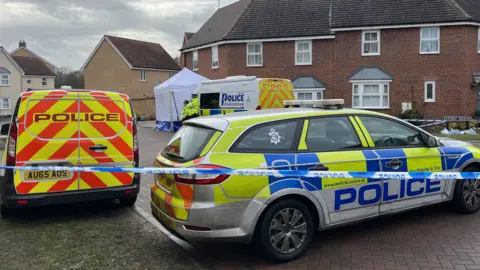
[137,123,480,269]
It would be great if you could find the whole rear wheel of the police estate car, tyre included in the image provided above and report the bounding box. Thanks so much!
[255,199,315,262]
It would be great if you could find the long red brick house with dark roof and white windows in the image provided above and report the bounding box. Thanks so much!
[181,0,480,119]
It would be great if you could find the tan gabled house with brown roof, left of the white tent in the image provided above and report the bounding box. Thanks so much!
[82,35,180,116]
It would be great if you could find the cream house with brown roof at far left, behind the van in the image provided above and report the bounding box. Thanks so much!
[0,41,56,115]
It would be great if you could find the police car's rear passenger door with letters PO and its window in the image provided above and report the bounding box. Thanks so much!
[297,116,382,225]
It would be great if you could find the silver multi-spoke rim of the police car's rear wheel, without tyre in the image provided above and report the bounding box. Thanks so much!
[269,208,309,254]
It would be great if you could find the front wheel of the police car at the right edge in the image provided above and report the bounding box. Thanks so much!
[453,166,480,214]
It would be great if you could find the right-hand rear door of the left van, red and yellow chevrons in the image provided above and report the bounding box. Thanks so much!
[79,91,133,190]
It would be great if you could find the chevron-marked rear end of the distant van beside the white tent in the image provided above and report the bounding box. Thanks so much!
[259,79,295,109]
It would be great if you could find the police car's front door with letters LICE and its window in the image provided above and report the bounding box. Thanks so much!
[357,116,445,212]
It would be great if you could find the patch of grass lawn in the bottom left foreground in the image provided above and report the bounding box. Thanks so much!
[0,202,204,270]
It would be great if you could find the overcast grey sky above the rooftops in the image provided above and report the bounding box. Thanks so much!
[0,0,235,69]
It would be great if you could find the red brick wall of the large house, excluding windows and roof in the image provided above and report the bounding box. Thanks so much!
[181,26,480,118]
